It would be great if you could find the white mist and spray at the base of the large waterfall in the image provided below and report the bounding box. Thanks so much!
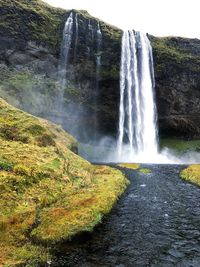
[78,136,200,165]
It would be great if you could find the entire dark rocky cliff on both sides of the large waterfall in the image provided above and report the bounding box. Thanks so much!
[0,0,200,140]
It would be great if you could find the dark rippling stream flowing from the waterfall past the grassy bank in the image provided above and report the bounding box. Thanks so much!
[51,165,200,267]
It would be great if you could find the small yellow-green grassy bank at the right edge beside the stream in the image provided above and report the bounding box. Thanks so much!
[180,165,200,186]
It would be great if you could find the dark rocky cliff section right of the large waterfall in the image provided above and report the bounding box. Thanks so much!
[151,37,200,138]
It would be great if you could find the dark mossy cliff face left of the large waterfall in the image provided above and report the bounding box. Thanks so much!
[0,0,121,142]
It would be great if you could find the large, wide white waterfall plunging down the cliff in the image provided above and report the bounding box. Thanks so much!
[118,31,158,161]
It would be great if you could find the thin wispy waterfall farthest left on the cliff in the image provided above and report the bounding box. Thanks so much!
[56,12,73,112]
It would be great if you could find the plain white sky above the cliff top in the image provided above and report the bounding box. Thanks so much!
[43,0,200,39]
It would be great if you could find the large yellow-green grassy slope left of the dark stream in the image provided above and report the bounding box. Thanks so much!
[0,99,127,266]
